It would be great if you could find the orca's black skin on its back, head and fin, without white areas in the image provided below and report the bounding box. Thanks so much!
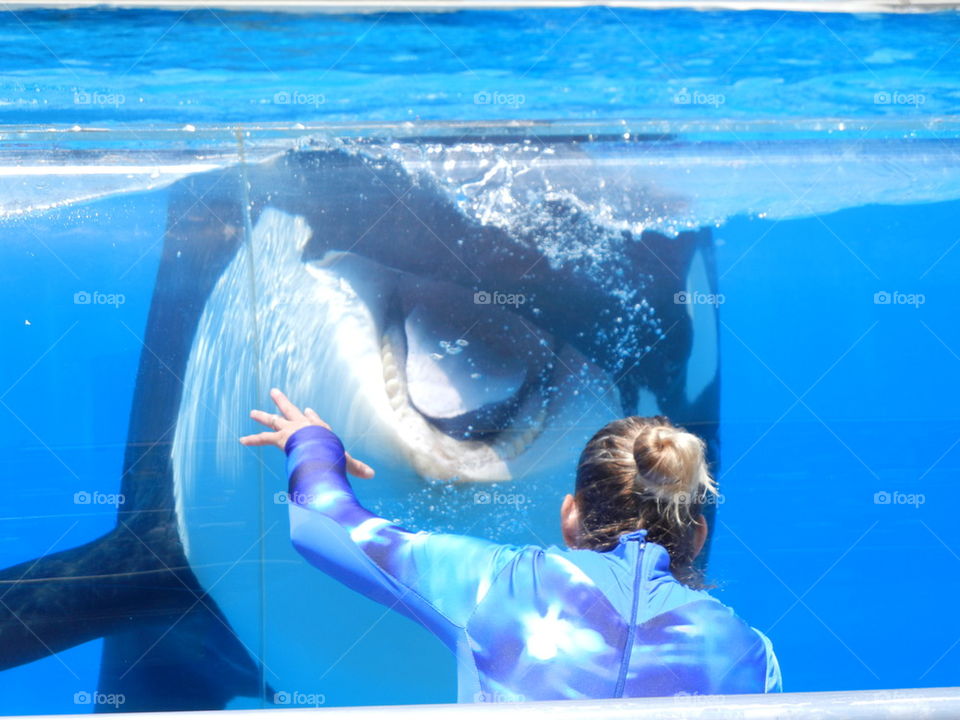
[0,145,719,712]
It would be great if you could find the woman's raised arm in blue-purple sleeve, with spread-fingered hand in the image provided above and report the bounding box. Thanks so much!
[241,391,519,646]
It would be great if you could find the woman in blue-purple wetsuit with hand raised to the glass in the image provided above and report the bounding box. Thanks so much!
[240,389,781,702]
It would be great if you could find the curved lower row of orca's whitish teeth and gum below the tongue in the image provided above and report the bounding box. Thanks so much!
[380,327,549,482]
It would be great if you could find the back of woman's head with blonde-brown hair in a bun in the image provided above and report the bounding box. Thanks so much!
[576,416,717,586]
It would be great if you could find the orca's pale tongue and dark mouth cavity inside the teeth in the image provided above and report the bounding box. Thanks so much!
[403,287,552,438]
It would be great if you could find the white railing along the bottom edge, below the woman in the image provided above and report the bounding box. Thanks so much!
[15,688,960,720]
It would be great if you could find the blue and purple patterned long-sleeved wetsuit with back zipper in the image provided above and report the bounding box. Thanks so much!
[286,426,781,702]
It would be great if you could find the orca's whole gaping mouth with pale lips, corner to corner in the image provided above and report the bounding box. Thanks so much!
[307,252,619,481]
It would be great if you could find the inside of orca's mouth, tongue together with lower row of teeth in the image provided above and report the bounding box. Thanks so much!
[380,270,557,476]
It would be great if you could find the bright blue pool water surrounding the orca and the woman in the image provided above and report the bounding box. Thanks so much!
[0,8,960,714]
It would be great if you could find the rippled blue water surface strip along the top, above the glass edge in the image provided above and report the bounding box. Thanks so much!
[0,8,960,125]
